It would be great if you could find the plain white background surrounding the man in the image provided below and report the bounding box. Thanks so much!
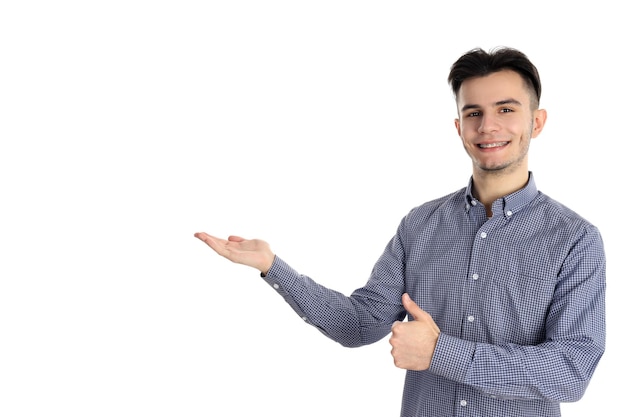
[0,0,626,417]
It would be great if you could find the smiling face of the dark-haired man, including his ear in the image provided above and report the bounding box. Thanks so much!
[455,70,546,175]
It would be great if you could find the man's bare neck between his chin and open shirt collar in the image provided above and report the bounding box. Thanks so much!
[472,169,529,216]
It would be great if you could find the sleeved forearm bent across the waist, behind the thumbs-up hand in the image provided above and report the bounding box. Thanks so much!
[430,334,604,402]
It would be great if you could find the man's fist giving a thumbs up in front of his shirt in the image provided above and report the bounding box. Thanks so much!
[389,293,440,371]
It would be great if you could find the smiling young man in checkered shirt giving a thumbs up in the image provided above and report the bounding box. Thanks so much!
[195,48,605,417]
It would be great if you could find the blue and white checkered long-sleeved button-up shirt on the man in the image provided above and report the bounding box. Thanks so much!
[264,173,606,417]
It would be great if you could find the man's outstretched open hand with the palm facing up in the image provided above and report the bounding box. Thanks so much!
[194,232,274,274]
